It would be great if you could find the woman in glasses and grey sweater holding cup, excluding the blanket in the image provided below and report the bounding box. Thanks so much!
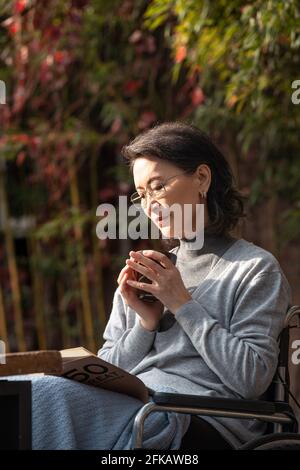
[98,122,291,448]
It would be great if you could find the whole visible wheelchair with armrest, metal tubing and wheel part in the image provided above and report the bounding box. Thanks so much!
[132,305,300,450]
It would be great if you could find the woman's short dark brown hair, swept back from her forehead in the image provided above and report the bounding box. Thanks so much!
[121,121,246,239]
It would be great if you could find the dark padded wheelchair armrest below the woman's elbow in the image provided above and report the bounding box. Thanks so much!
[152,392,278,414]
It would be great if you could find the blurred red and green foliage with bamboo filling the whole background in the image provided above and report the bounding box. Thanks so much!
[0,0,300,370]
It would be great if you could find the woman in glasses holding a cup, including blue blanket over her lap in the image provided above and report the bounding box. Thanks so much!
[4,122,291,449]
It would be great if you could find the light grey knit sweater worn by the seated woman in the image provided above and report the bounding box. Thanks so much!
[98,235,292,446]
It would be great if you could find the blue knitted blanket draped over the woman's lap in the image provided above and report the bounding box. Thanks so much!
[3,375,190,450]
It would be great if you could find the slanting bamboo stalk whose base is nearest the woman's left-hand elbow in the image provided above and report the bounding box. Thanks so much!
[68,154,96,352]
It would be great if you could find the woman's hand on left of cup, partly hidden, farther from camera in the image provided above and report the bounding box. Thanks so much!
[117,257,164,331]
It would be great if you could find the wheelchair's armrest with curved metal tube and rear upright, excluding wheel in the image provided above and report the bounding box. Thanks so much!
[131,305,300,450]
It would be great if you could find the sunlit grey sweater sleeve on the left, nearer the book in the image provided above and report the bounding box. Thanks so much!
[97,288,156,371]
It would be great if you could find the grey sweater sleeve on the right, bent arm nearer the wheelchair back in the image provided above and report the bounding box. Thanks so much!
[175,271,291,399]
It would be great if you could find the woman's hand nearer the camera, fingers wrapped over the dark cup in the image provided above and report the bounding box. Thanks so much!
[126,250,192,314]
